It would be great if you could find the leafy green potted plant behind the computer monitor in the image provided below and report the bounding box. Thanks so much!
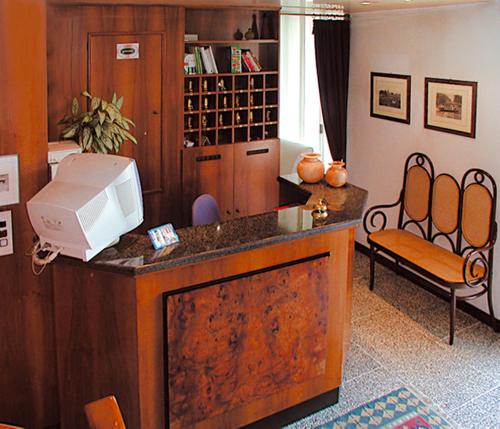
[59,91,137,153]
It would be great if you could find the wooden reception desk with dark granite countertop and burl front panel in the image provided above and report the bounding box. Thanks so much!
[54,176,367,429]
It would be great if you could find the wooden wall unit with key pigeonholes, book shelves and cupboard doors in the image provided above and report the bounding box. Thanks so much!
[182,8,279,223]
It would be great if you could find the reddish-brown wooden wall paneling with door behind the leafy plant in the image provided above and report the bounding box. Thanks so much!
[48,6,184,229]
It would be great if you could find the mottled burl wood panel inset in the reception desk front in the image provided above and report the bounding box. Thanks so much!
[166,258,329,427]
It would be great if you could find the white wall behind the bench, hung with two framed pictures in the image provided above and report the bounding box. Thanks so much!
[347,0,500,318]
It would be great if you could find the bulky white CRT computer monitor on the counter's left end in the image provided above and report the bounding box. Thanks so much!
[27,153,143,265]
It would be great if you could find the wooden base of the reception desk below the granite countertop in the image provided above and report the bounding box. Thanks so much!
[54,228,354,429]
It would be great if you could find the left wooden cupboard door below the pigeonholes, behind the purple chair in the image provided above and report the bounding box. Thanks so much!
[182,145,233,224]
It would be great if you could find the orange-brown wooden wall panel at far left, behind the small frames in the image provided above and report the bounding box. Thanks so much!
[0,0,58,429]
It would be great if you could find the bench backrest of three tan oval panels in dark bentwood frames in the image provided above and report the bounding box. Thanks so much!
[398,153,497,255]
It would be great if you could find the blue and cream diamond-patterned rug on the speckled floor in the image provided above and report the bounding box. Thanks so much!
[316,388,451,429]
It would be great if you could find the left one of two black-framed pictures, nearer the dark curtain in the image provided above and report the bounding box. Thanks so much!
[370,72,411,124]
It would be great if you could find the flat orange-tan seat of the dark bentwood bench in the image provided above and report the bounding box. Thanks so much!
[369,229,484,285]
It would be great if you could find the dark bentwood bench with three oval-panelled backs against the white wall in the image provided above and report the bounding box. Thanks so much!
[363,153,497,345]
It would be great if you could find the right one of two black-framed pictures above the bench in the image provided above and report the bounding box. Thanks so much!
[424,77,477,138]
